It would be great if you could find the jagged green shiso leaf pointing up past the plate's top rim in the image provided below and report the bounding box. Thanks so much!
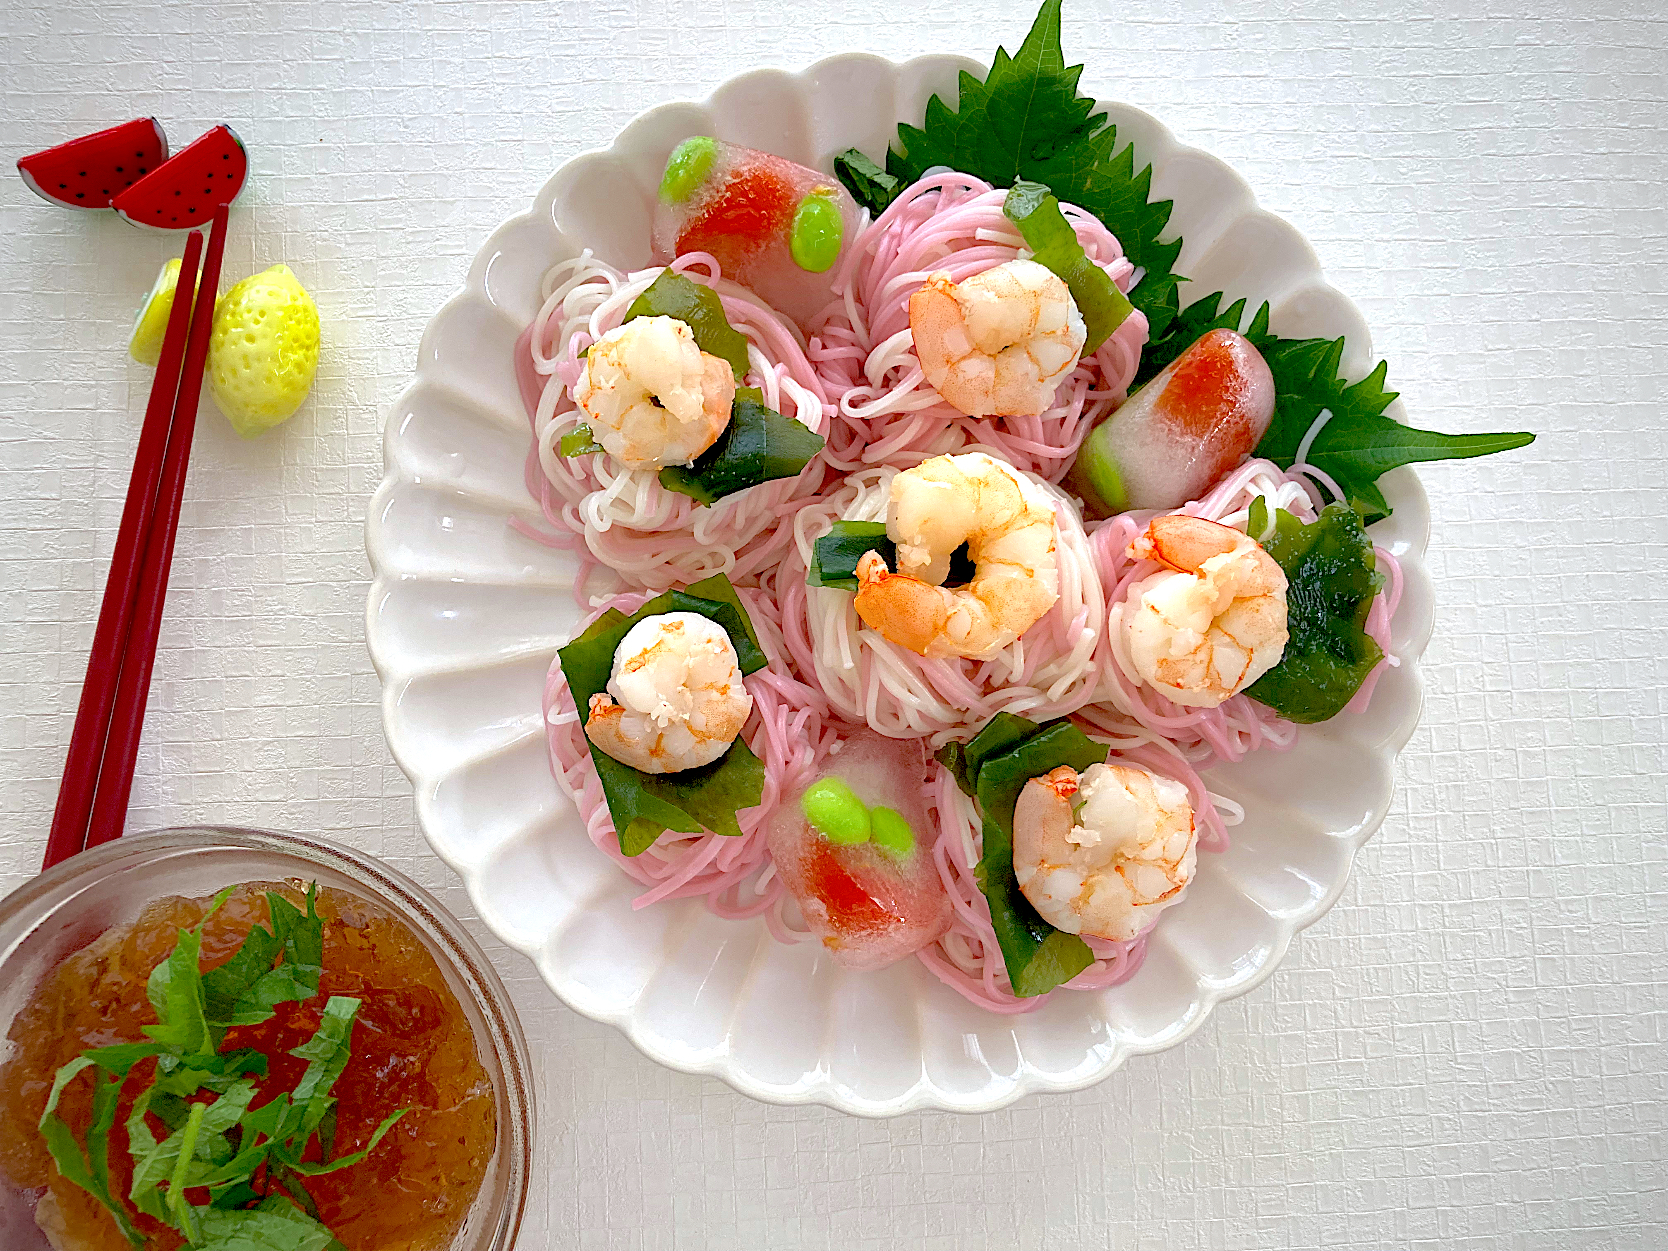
[887,0,1181,335]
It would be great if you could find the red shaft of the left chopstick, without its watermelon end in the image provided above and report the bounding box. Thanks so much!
[42,230,203,869]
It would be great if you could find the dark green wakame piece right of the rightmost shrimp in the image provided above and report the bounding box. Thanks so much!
[1246,495,1384,724]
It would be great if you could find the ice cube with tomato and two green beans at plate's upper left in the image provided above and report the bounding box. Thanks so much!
[652,135,861,329]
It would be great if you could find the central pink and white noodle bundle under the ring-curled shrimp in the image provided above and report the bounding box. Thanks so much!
[777,463,1106,746]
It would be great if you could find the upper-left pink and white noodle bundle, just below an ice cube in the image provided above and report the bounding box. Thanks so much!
[515,252,834,604]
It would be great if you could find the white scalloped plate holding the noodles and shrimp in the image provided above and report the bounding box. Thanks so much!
[365,57,1431,1116]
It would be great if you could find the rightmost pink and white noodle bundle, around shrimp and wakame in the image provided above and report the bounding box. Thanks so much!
[1084,460,1401,760]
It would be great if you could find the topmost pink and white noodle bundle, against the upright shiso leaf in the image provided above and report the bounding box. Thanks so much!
[811,173,1148,482]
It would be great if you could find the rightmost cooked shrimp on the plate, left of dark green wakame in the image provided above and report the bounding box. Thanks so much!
[1124,514,1286,707]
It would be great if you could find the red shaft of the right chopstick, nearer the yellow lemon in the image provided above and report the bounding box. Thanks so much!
[87,209,227,847]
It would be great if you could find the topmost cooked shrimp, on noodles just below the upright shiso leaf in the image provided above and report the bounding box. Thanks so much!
[909,260,1088,417]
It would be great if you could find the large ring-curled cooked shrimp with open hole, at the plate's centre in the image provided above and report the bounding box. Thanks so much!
[857,452,1059,659]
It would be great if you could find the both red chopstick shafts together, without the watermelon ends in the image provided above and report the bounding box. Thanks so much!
[42,207,227,869]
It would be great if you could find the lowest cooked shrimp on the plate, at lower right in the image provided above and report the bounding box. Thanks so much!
[1014,764,1196,942]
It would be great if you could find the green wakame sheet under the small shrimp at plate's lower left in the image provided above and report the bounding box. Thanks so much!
[557,574,769,856]
